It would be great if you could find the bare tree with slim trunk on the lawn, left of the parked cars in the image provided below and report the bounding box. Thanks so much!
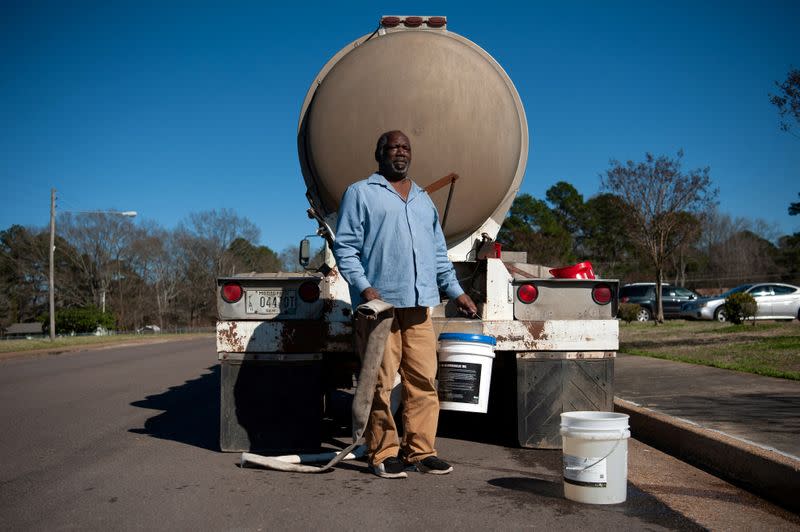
[601,150,717,323]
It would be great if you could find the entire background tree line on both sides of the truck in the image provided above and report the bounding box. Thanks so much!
[0,164,800,333]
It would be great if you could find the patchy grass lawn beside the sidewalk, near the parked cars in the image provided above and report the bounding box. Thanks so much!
[619,320,800,380]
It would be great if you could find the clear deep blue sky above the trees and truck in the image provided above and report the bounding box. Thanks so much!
[0,0,800,251]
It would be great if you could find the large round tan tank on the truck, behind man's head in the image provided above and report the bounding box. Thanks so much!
[298,17,528,249]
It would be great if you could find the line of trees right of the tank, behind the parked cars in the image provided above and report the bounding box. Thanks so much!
[498,158,800,298]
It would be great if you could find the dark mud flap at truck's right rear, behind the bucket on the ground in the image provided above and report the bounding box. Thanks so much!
[517,358,614,449]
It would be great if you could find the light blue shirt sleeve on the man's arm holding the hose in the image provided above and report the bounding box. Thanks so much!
[333,186,371,294]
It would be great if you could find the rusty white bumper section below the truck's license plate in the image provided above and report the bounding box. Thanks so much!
[217,320,353,353]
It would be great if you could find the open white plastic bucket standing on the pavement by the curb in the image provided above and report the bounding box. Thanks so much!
[561,412,631,504]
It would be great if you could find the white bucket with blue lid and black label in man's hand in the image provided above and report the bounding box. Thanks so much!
[437,333,497,413]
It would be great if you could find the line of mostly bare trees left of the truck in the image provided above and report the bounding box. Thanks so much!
[0,209,296,333]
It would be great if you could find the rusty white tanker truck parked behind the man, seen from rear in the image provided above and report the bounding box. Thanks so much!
[217,16,619,451]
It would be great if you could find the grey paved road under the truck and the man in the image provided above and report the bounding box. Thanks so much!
[0,339,800,530]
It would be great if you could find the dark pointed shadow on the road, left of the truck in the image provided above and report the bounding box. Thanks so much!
[129,365,220,451]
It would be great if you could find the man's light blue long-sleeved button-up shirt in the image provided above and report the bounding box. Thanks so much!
[333,174,464,308]
